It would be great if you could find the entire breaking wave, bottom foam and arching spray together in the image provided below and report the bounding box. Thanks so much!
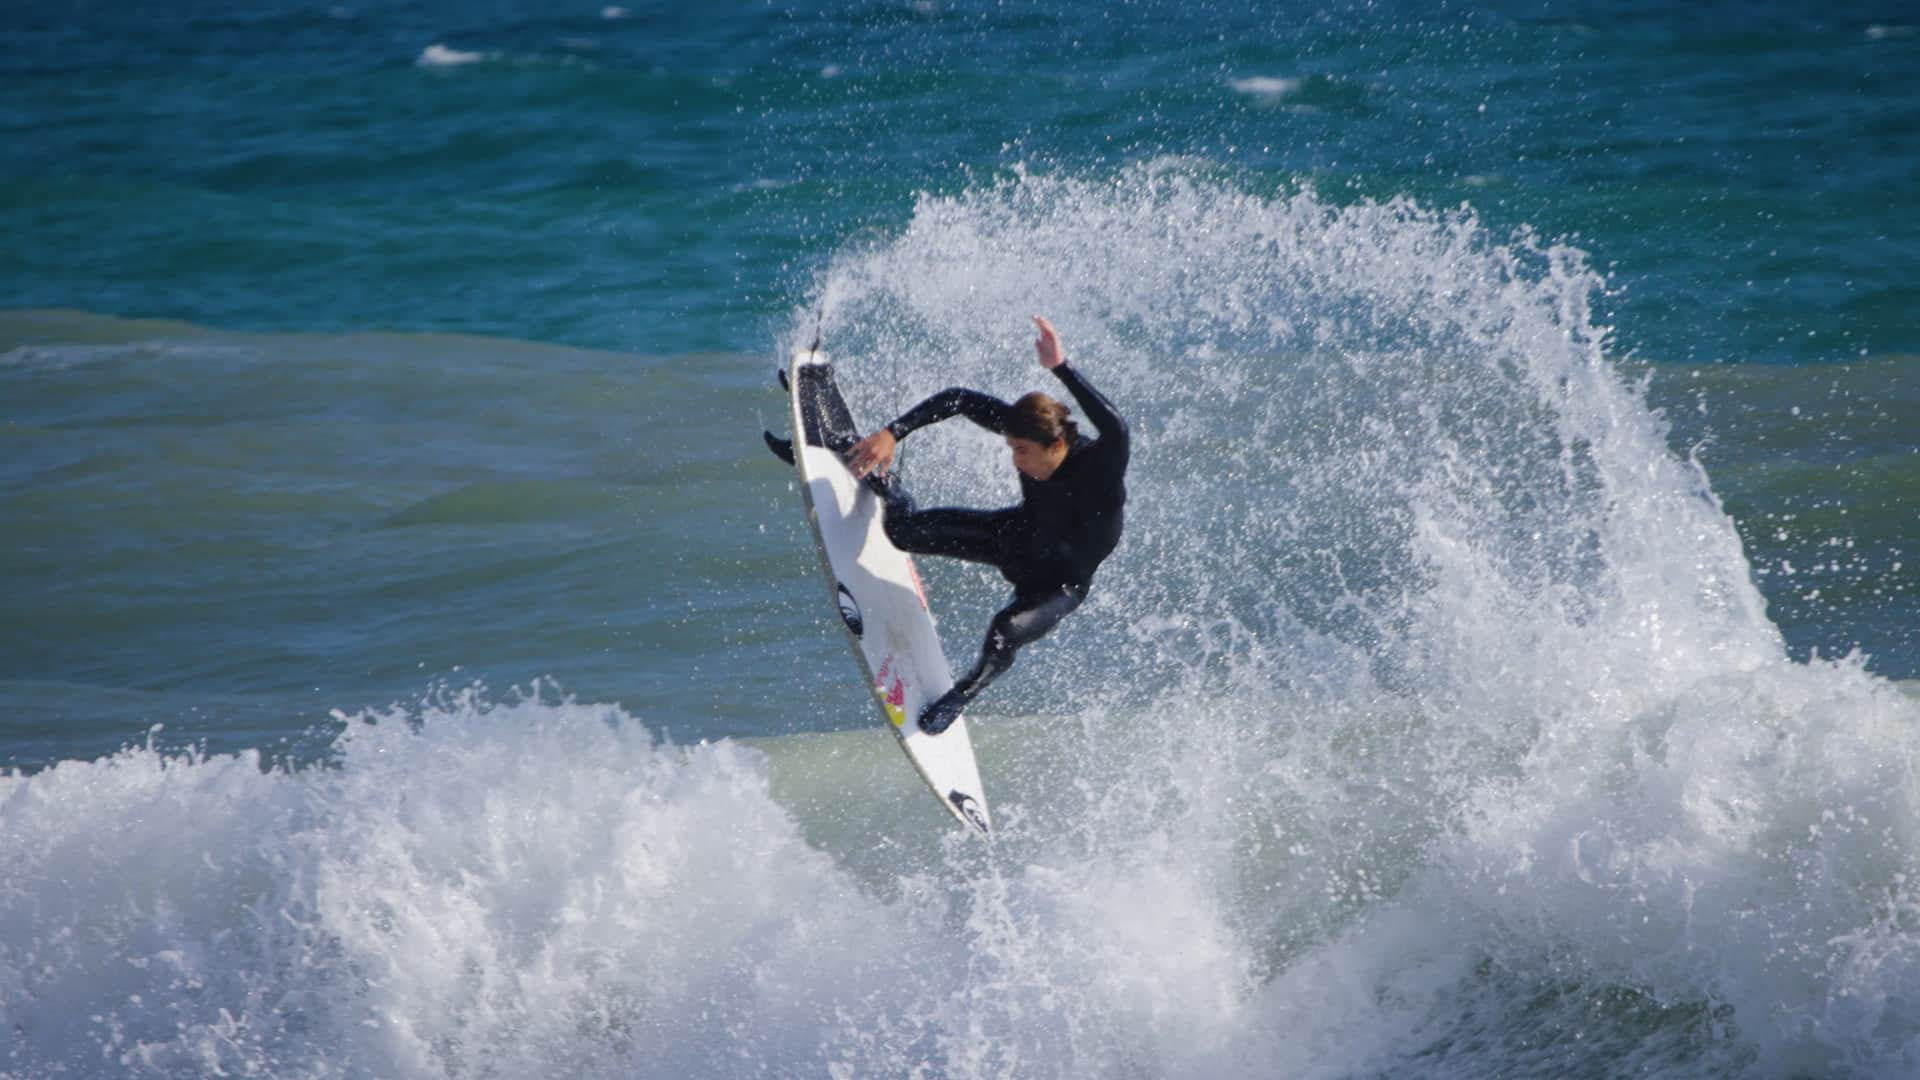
[11,161,1920,1078]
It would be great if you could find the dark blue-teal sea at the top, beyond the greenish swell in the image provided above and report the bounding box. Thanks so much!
[0,2,1920,363]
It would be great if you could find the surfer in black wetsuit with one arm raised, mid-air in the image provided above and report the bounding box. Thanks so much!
[847,315,1129,734]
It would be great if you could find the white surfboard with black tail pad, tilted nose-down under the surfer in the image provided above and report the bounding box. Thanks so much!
[787,350,991,836]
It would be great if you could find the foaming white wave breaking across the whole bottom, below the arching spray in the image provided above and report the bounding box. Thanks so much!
[0,645,1920,1078]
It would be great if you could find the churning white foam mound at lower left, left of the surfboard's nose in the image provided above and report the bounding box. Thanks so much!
[0,692,929,1076]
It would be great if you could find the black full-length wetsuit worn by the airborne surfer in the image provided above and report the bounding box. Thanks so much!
[885,363,1131,734]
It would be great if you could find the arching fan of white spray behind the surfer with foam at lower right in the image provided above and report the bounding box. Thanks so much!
[795,161,1920,1074]
